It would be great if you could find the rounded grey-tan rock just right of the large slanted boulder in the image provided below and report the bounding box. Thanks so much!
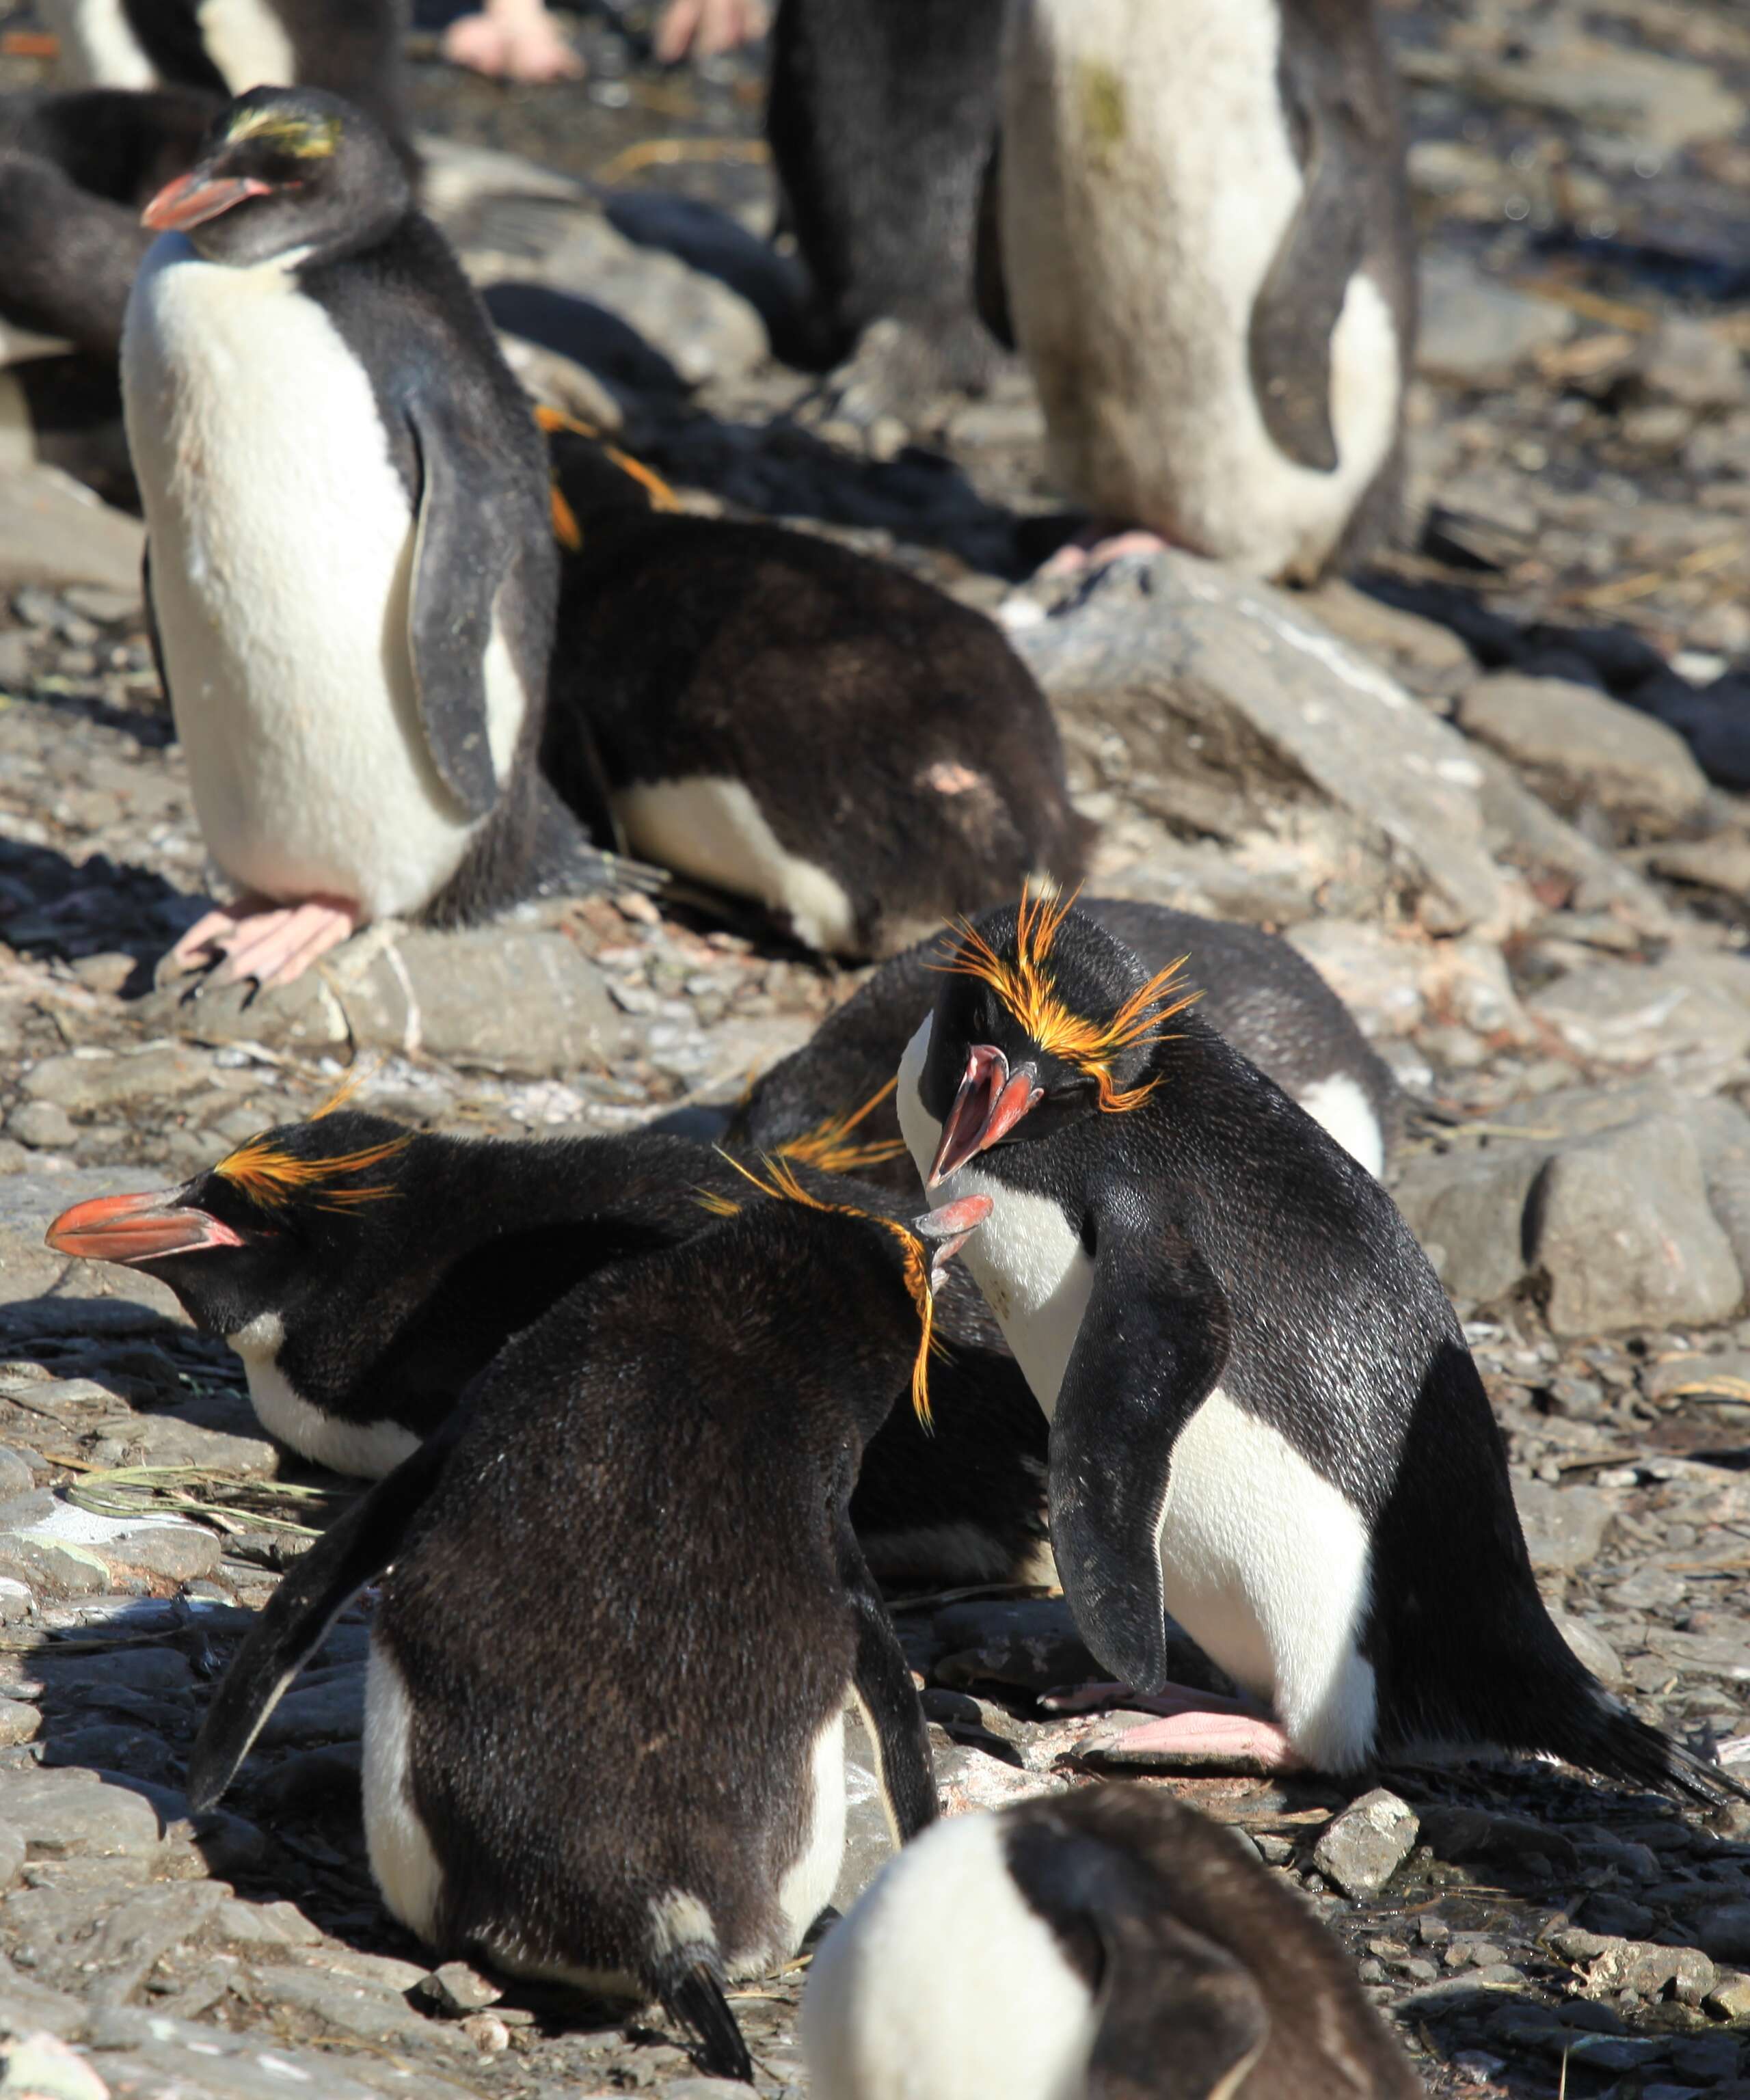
[1456,670,1708,838]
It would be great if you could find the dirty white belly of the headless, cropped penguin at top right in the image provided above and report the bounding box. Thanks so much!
[1002,0,1401,576]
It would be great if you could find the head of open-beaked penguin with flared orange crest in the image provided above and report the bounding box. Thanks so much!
[920,897,1198,1189]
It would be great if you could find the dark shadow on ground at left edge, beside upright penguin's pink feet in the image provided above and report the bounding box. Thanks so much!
[0,838,206,999]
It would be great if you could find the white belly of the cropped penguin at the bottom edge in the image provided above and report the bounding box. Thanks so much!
[803,1814,1099,2100]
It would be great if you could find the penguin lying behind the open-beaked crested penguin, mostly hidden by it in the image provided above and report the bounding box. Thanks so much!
[725,897,1405,1193]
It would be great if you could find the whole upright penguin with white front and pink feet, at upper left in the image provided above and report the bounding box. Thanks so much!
[122,88,621,983]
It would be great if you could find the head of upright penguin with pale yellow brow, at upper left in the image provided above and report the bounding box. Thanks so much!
[141,88,414,267]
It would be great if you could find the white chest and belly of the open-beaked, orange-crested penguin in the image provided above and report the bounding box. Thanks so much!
[895,1021,1376,1771]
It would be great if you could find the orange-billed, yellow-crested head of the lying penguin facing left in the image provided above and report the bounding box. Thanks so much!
[46,1111,414,1336]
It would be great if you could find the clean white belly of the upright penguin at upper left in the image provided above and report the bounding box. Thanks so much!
[122,233,523,917]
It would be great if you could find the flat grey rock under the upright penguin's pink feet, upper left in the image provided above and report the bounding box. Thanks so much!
[135,920,636,1077]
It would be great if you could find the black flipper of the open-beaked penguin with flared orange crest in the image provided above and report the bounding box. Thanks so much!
[1051,1205,1229,1693]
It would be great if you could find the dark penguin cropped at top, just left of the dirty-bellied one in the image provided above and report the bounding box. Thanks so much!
[765,0,1004,422]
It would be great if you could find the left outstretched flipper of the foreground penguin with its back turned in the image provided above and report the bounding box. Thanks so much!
[187,1407,466,1812]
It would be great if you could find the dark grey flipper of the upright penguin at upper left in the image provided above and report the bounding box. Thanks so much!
[407,397,514,817]
